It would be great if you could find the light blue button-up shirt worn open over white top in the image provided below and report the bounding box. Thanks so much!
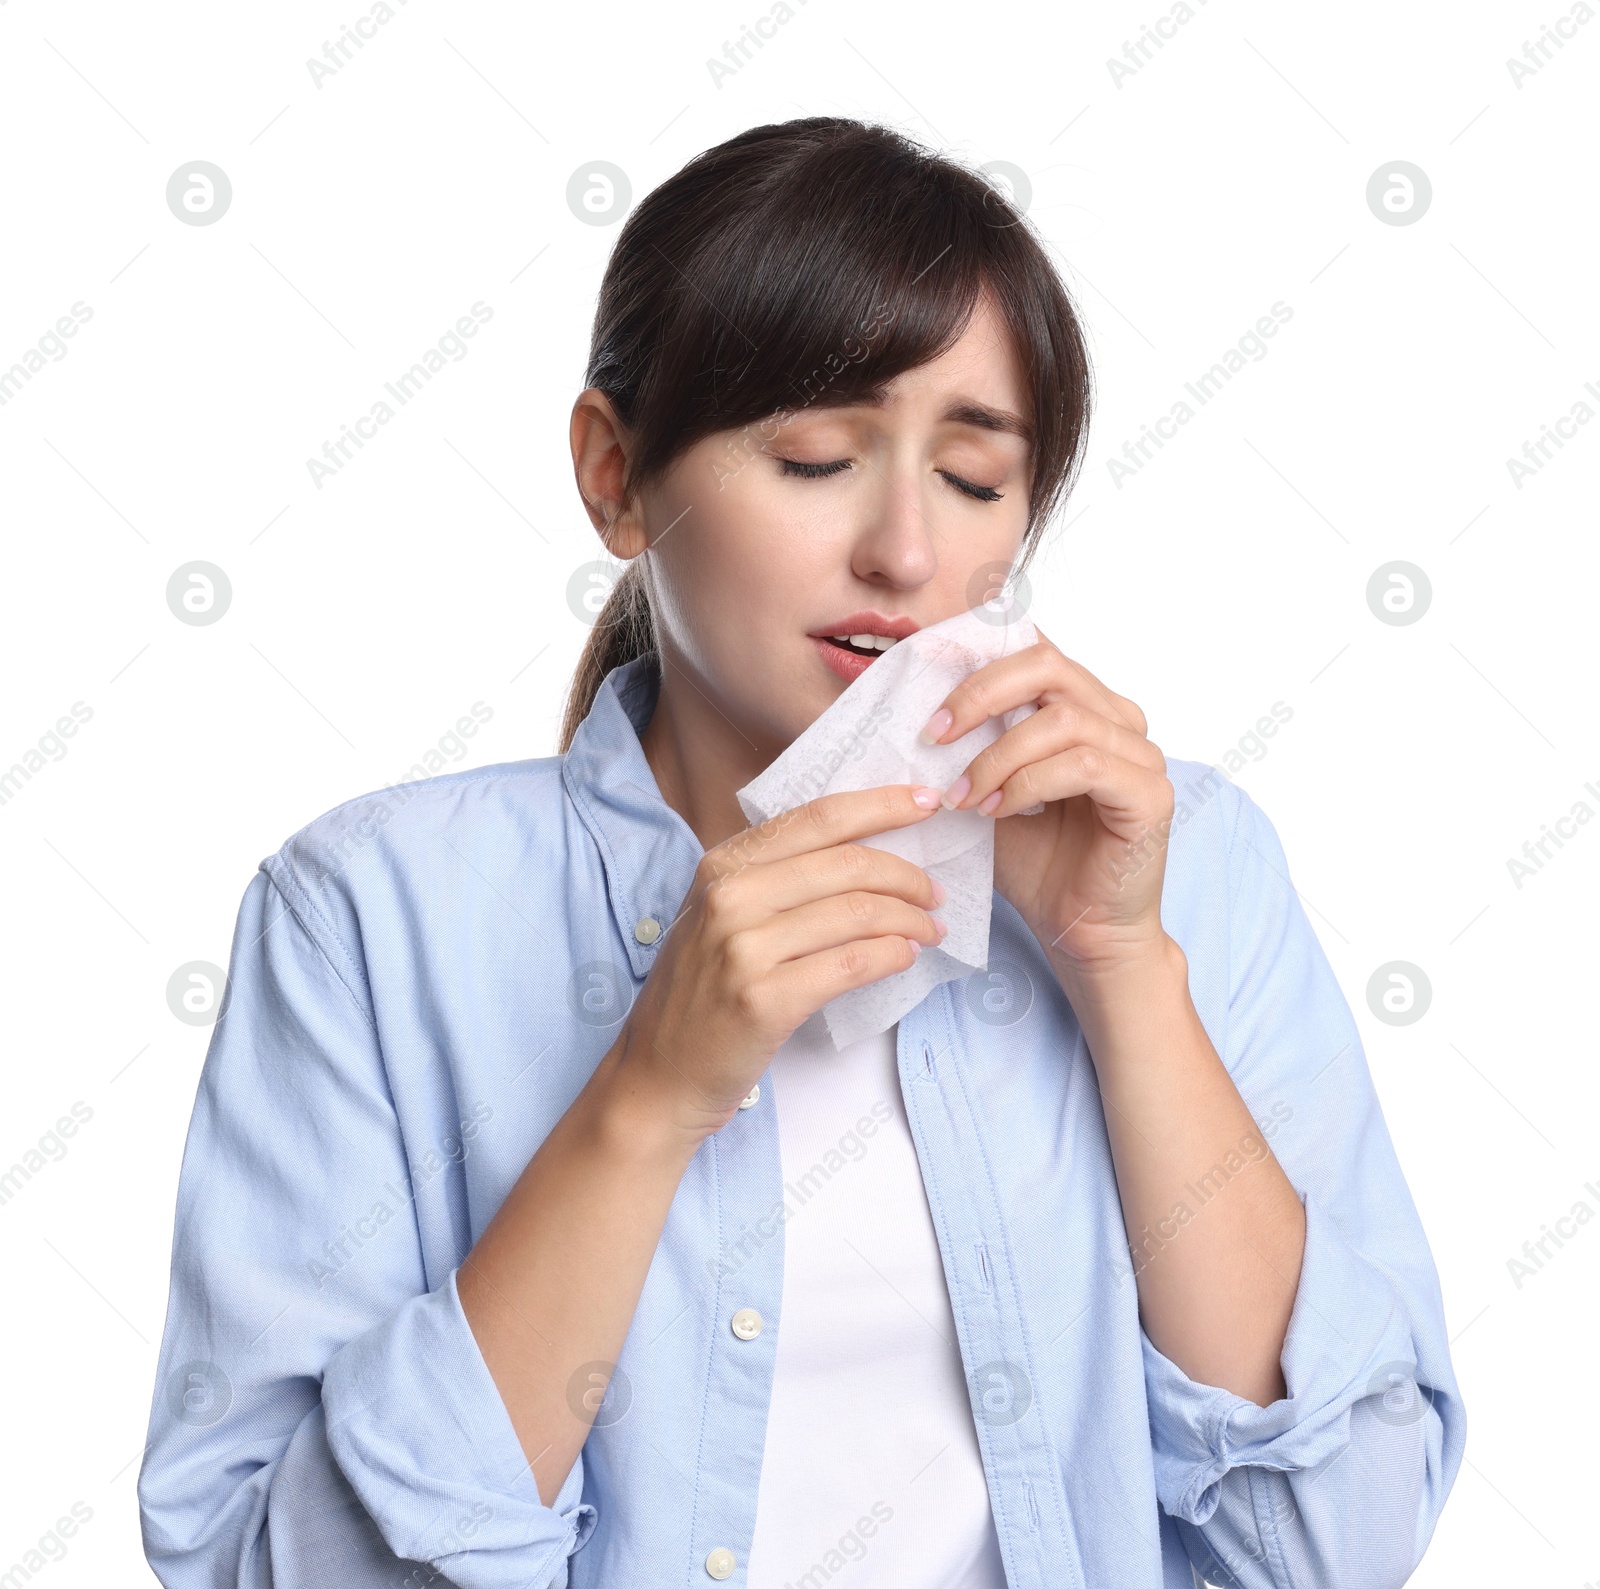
[139,661,1466,1589]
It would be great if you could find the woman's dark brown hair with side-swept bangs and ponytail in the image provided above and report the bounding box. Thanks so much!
[560,117,1091,754]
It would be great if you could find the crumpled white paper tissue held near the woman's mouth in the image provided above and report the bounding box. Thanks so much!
[738,605,1043,1048]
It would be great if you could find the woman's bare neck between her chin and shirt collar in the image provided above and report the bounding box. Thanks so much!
[638,653,782,850]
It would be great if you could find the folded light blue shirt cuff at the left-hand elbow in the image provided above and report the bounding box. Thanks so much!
[322,1269,598,1589]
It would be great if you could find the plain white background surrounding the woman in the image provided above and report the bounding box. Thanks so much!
[0,0,1600,1589]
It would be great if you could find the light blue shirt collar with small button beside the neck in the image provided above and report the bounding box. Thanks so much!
[562,653,706,976]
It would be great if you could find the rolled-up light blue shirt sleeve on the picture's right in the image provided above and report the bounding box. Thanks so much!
[1142,787,1466,1589]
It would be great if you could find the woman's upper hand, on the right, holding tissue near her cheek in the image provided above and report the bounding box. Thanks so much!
[930,634,1174,976]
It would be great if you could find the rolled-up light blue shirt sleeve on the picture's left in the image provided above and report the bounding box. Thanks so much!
[139,869,595,1589]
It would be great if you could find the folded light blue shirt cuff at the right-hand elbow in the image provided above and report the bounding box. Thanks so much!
[1139,1195,1426,1527]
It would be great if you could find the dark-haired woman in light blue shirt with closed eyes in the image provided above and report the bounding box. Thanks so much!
[139,118,1464,1589]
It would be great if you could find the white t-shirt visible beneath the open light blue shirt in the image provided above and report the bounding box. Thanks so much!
[747,1011,1006,1589]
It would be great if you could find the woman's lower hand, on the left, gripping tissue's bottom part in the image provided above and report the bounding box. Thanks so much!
[614,784,946,1144]
